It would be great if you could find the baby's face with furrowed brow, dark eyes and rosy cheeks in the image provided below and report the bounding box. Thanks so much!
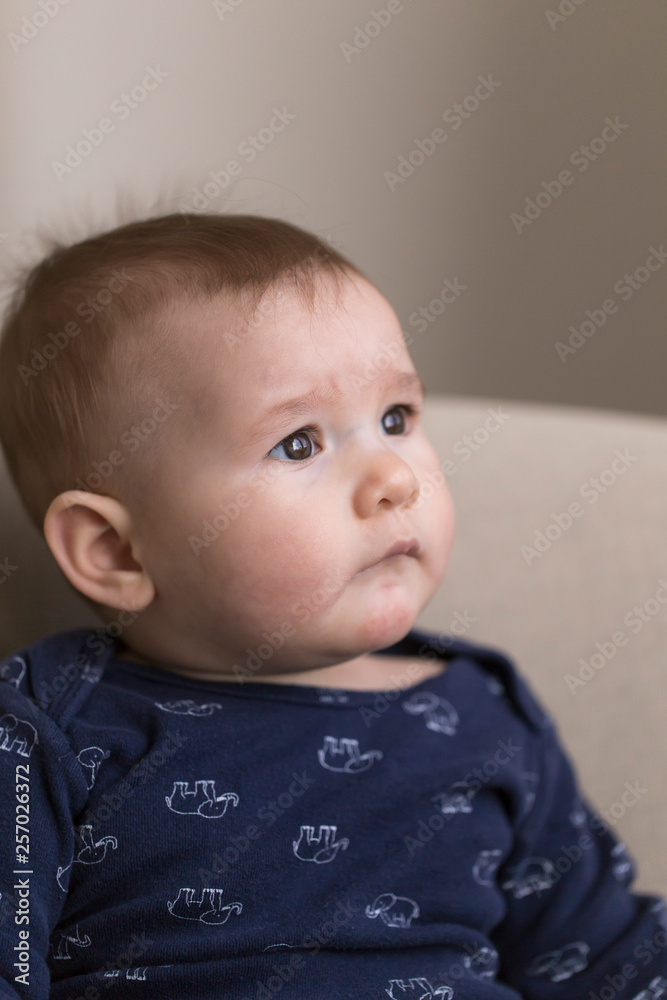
[130,270,454,678]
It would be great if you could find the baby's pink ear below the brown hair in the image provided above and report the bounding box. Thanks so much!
[44,490,155,611]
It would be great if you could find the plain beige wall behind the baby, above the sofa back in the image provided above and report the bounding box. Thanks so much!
[0,0,667,414]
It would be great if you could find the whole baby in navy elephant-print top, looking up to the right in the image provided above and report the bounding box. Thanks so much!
[0,215,667,1000]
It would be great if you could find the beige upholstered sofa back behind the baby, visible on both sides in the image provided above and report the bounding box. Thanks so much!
[0,397,667,895]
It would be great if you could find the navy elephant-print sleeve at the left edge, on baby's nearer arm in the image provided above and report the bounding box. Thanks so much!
[0,657,86,1000]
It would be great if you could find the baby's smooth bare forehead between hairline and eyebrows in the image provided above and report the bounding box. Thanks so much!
[158,274,404,392]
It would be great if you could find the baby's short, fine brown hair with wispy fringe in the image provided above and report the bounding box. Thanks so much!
[0,213,363,531]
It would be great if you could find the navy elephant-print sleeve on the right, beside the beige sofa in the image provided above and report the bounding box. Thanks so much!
[493,724,667,1000]
